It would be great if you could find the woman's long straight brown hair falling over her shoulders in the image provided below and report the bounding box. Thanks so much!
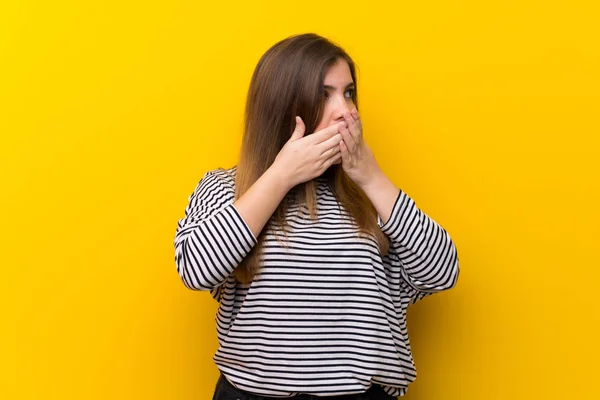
[230,33,389,283]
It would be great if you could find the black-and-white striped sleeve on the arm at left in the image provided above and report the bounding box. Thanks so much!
[174,170,257,290]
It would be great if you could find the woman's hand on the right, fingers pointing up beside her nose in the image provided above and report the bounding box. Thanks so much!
[340,109,379,188]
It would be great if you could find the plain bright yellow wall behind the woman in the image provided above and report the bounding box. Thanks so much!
[0,0,600,400]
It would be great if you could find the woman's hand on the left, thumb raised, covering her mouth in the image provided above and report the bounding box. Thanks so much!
[273,117,346,189]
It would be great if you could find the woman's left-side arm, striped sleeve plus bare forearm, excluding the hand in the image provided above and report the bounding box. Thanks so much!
[174,167,289,290]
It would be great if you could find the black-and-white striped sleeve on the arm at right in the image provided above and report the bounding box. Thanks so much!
[377,190,460,303]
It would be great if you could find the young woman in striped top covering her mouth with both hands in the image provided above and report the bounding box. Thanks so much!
[175,34,459,400]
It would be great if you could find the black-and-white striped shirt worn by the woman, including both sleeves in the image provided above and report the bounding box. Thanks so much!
[174,166,459,397]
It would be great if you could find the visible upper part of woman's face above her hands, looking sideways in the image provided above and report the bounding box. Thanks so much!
[315,59,355,132]
